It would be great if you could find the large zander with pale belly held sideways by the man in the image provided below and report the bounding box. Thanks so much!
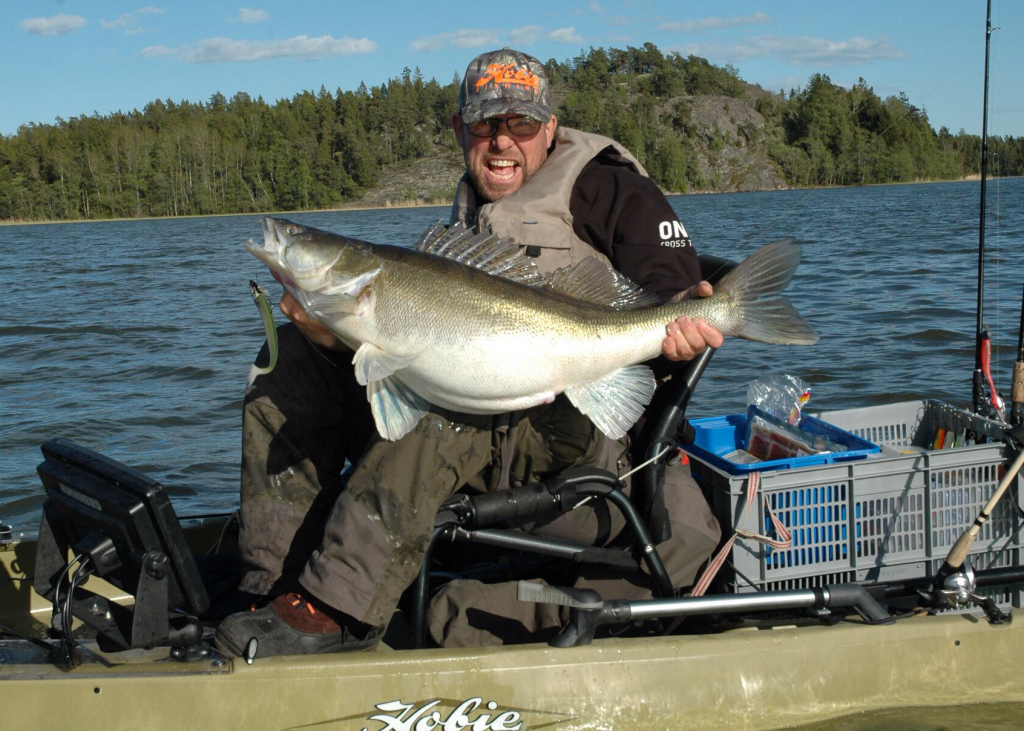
[247,217,817,439]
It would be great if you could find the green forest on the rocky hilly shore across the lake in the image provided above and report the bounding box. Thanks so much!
[0,43,1024,220]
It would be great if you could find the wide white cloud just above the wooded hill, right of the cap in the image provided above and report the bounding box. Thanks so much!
[668,36,906,68]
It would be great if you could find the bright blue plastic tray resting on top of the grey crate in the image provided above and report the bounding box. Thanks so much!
[683,414,882,475]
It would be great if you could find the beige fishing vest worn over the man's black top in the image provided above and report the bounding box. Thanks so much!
[451,127,647,275]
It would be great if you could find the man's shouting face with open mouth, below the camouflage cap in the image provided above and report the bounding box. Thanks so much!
[452,113,558,203]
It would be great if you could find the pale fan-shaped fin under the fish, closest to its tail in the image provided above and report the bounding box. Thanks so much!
[565,366,656,439]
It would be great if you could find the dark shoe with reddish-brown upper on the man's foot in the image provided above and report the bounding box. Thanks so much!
[214,594,384,657]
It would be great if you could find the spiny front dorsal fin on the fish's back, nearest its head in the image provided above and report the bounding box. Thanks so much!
[416,221,544,287]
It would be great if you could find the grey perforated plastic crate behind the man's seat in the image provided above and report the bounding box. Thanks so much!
[691,400,1021,607]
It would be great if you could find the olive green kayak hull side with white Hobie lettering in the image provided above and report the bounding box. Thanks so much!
[0,532,1024,731]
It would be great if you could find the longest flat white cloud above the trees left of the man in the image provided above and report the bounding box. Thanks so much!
[139,36,377,63]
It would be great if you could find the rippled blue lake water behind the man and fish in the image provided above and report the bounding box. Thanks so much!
[0,179,1024,533]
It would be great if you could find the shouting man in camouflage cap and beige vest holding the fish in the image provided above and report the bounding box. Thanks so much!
[217,48,722,655]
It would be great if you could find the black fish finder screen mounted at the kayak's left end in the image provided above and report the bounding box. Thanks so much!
[35,438,210,649]
